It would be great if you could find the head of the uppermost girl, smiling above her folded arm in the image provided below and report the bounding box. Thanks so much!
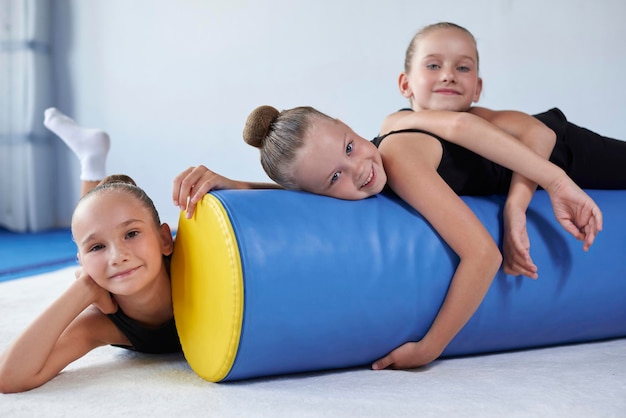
[399,28,482,112]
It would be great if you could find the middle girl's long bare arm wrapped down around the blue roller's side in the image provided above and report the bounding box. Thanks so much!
[372,133,502,369]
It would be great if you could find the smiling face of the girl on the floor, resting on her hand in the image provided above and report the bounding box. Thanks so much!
[72,190,172,295]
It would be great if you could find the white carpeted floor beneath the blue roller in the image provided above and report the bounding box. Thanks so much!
[0,267,626,417]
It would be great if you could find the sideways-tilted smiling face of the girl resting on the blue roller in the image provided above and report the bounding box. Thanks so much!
[292,119,387,200]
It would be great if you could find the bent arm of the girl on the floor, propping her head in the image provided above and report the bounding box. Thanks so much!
[0,274,129,393]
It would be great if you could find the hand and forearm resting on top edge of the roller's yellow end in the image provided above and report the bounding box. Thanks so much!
[172,165,281,218]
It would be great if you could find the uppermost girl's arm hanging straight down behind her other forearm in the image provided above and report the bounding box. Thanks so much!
[470,107,556,279]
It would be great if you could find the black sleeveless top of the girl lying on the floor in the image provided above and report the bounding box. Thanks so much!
[107,308,182,354]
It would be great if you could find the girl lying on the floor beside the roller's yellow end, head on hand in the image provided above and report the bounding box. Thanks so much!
[0,109,181,393]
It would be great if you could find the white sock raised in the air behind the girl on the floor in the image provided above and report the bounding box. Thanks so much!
[43,107,111,181]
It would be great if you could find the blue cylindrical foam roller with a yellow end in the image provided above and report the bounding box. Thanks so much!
[172,190,626,381]
